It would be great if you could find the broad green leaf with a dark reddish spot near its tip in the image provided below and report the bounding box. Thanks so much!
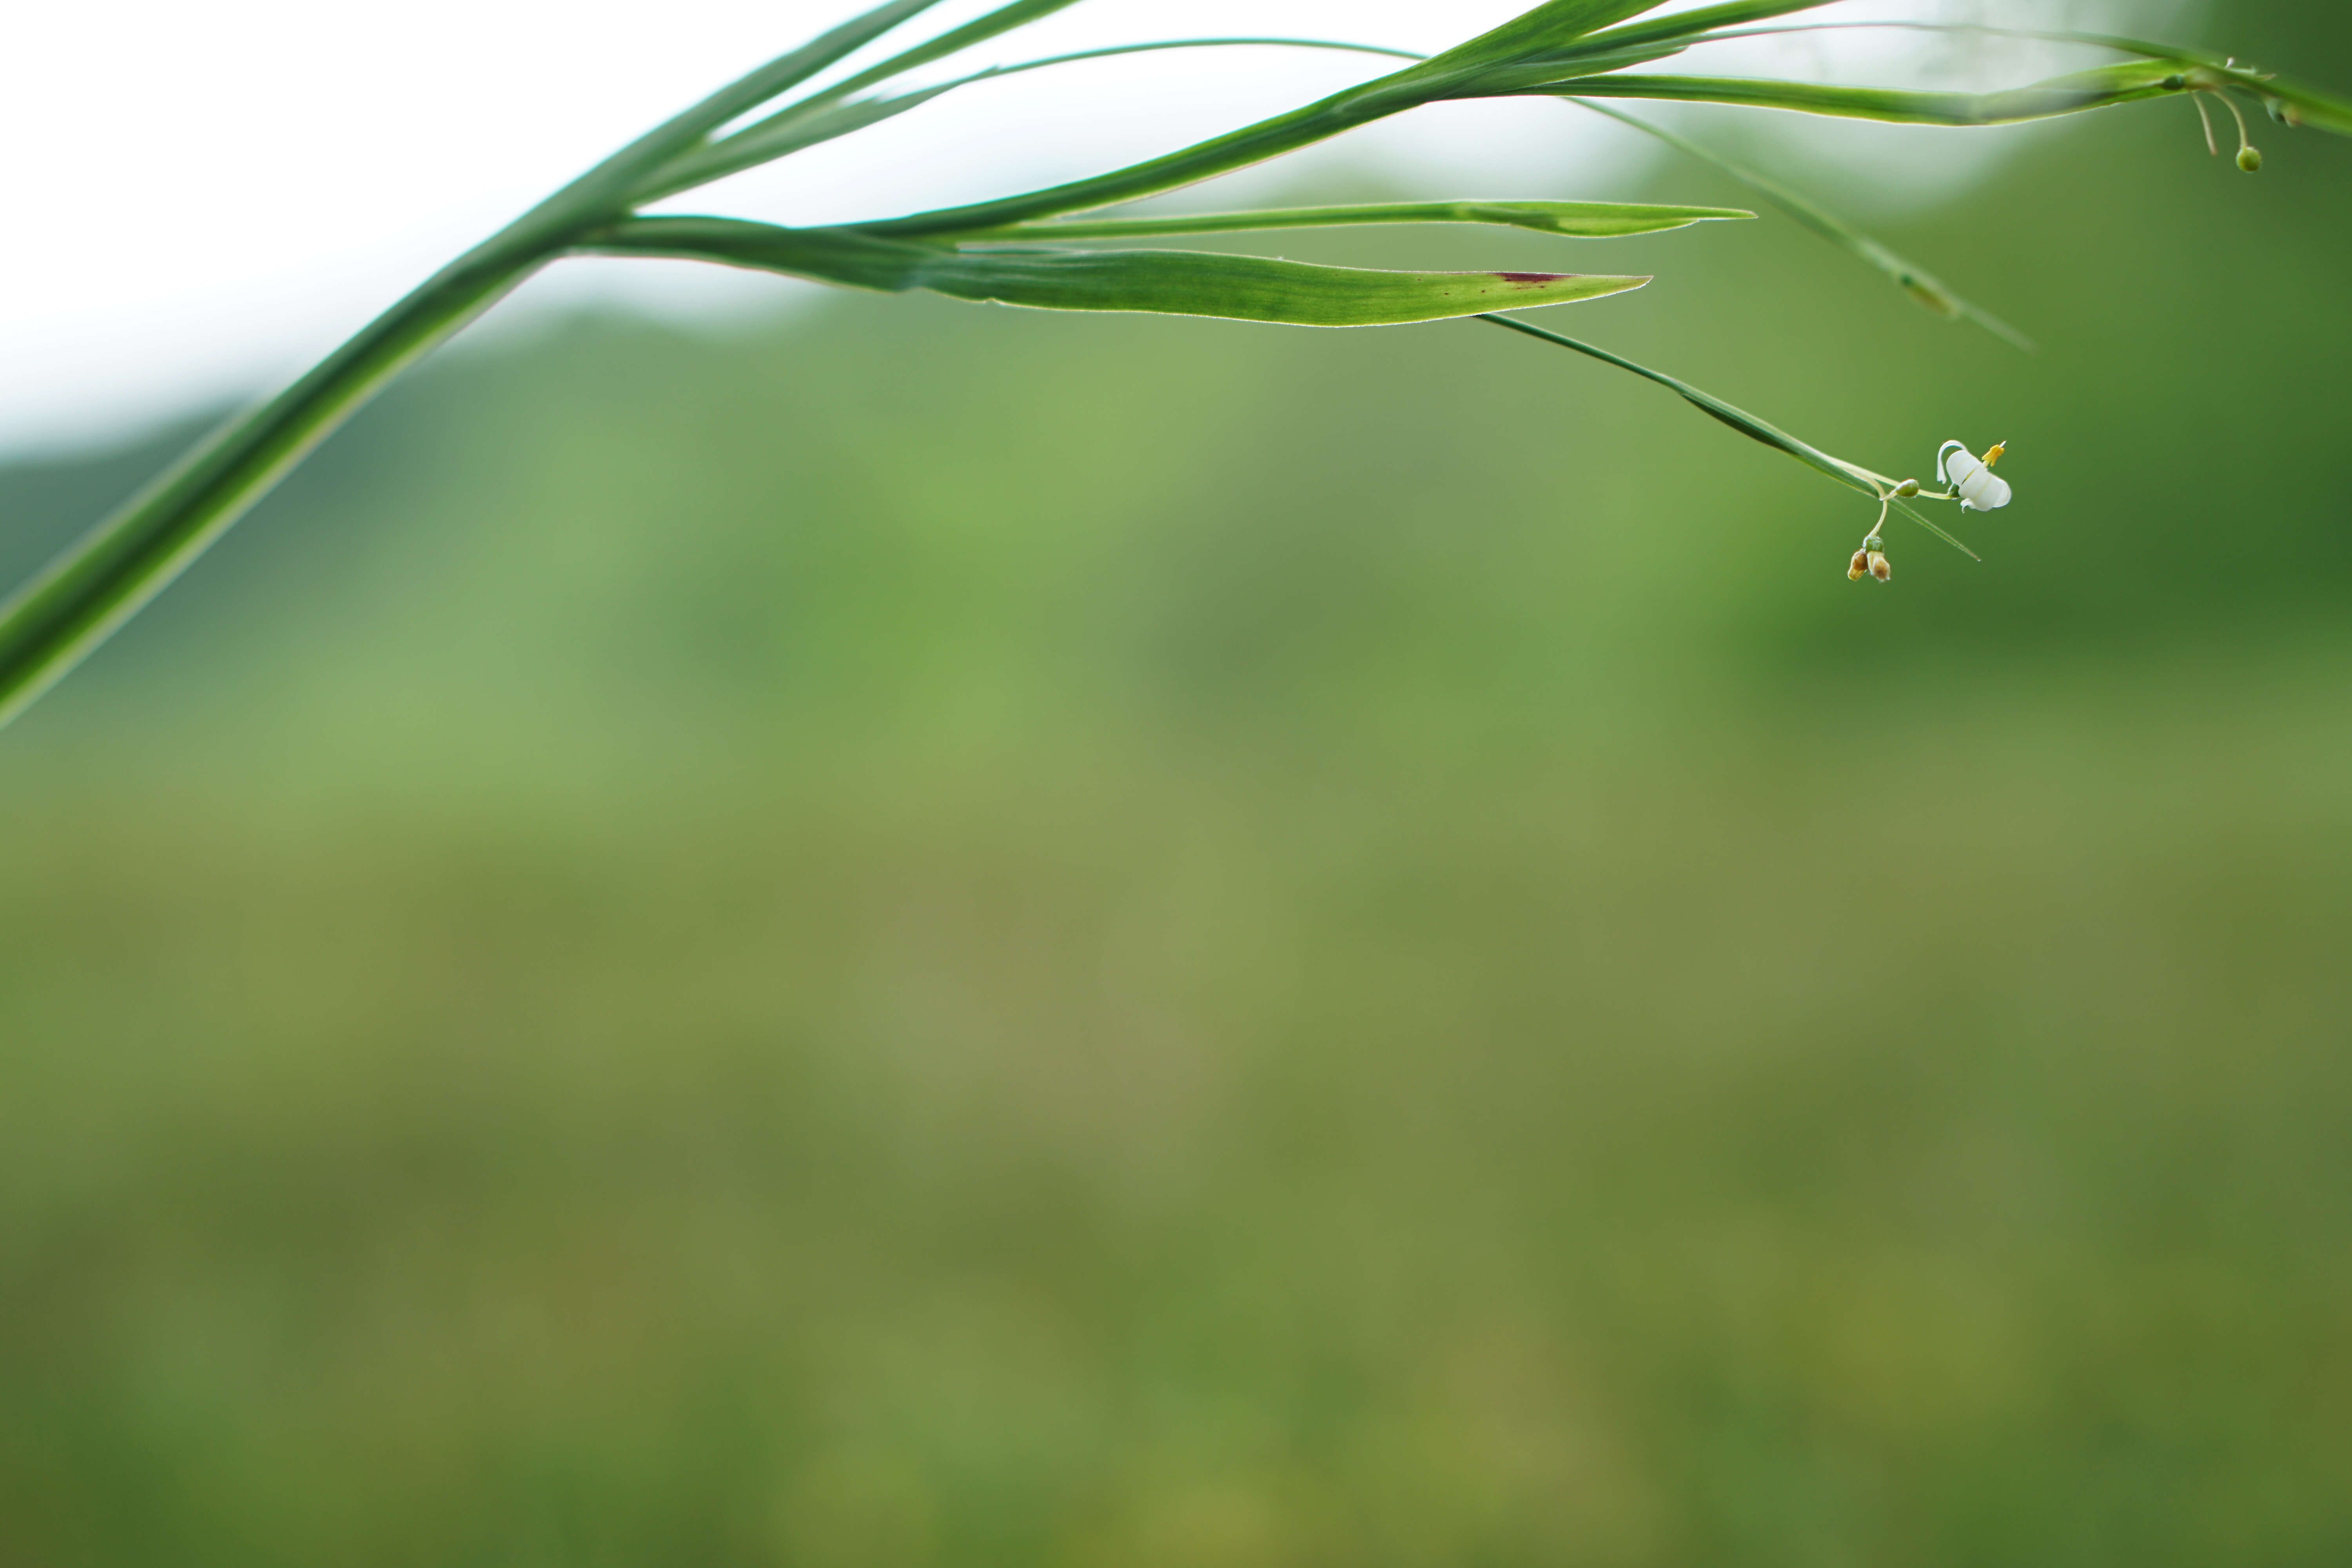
[579,219,1649,327]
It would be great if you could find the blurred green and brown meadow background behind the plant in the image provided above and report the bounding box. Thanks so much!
[0,0,2352,1568]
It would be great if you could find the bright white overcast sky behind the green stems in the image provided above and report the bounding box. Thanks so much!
[0,0,2178,454]
